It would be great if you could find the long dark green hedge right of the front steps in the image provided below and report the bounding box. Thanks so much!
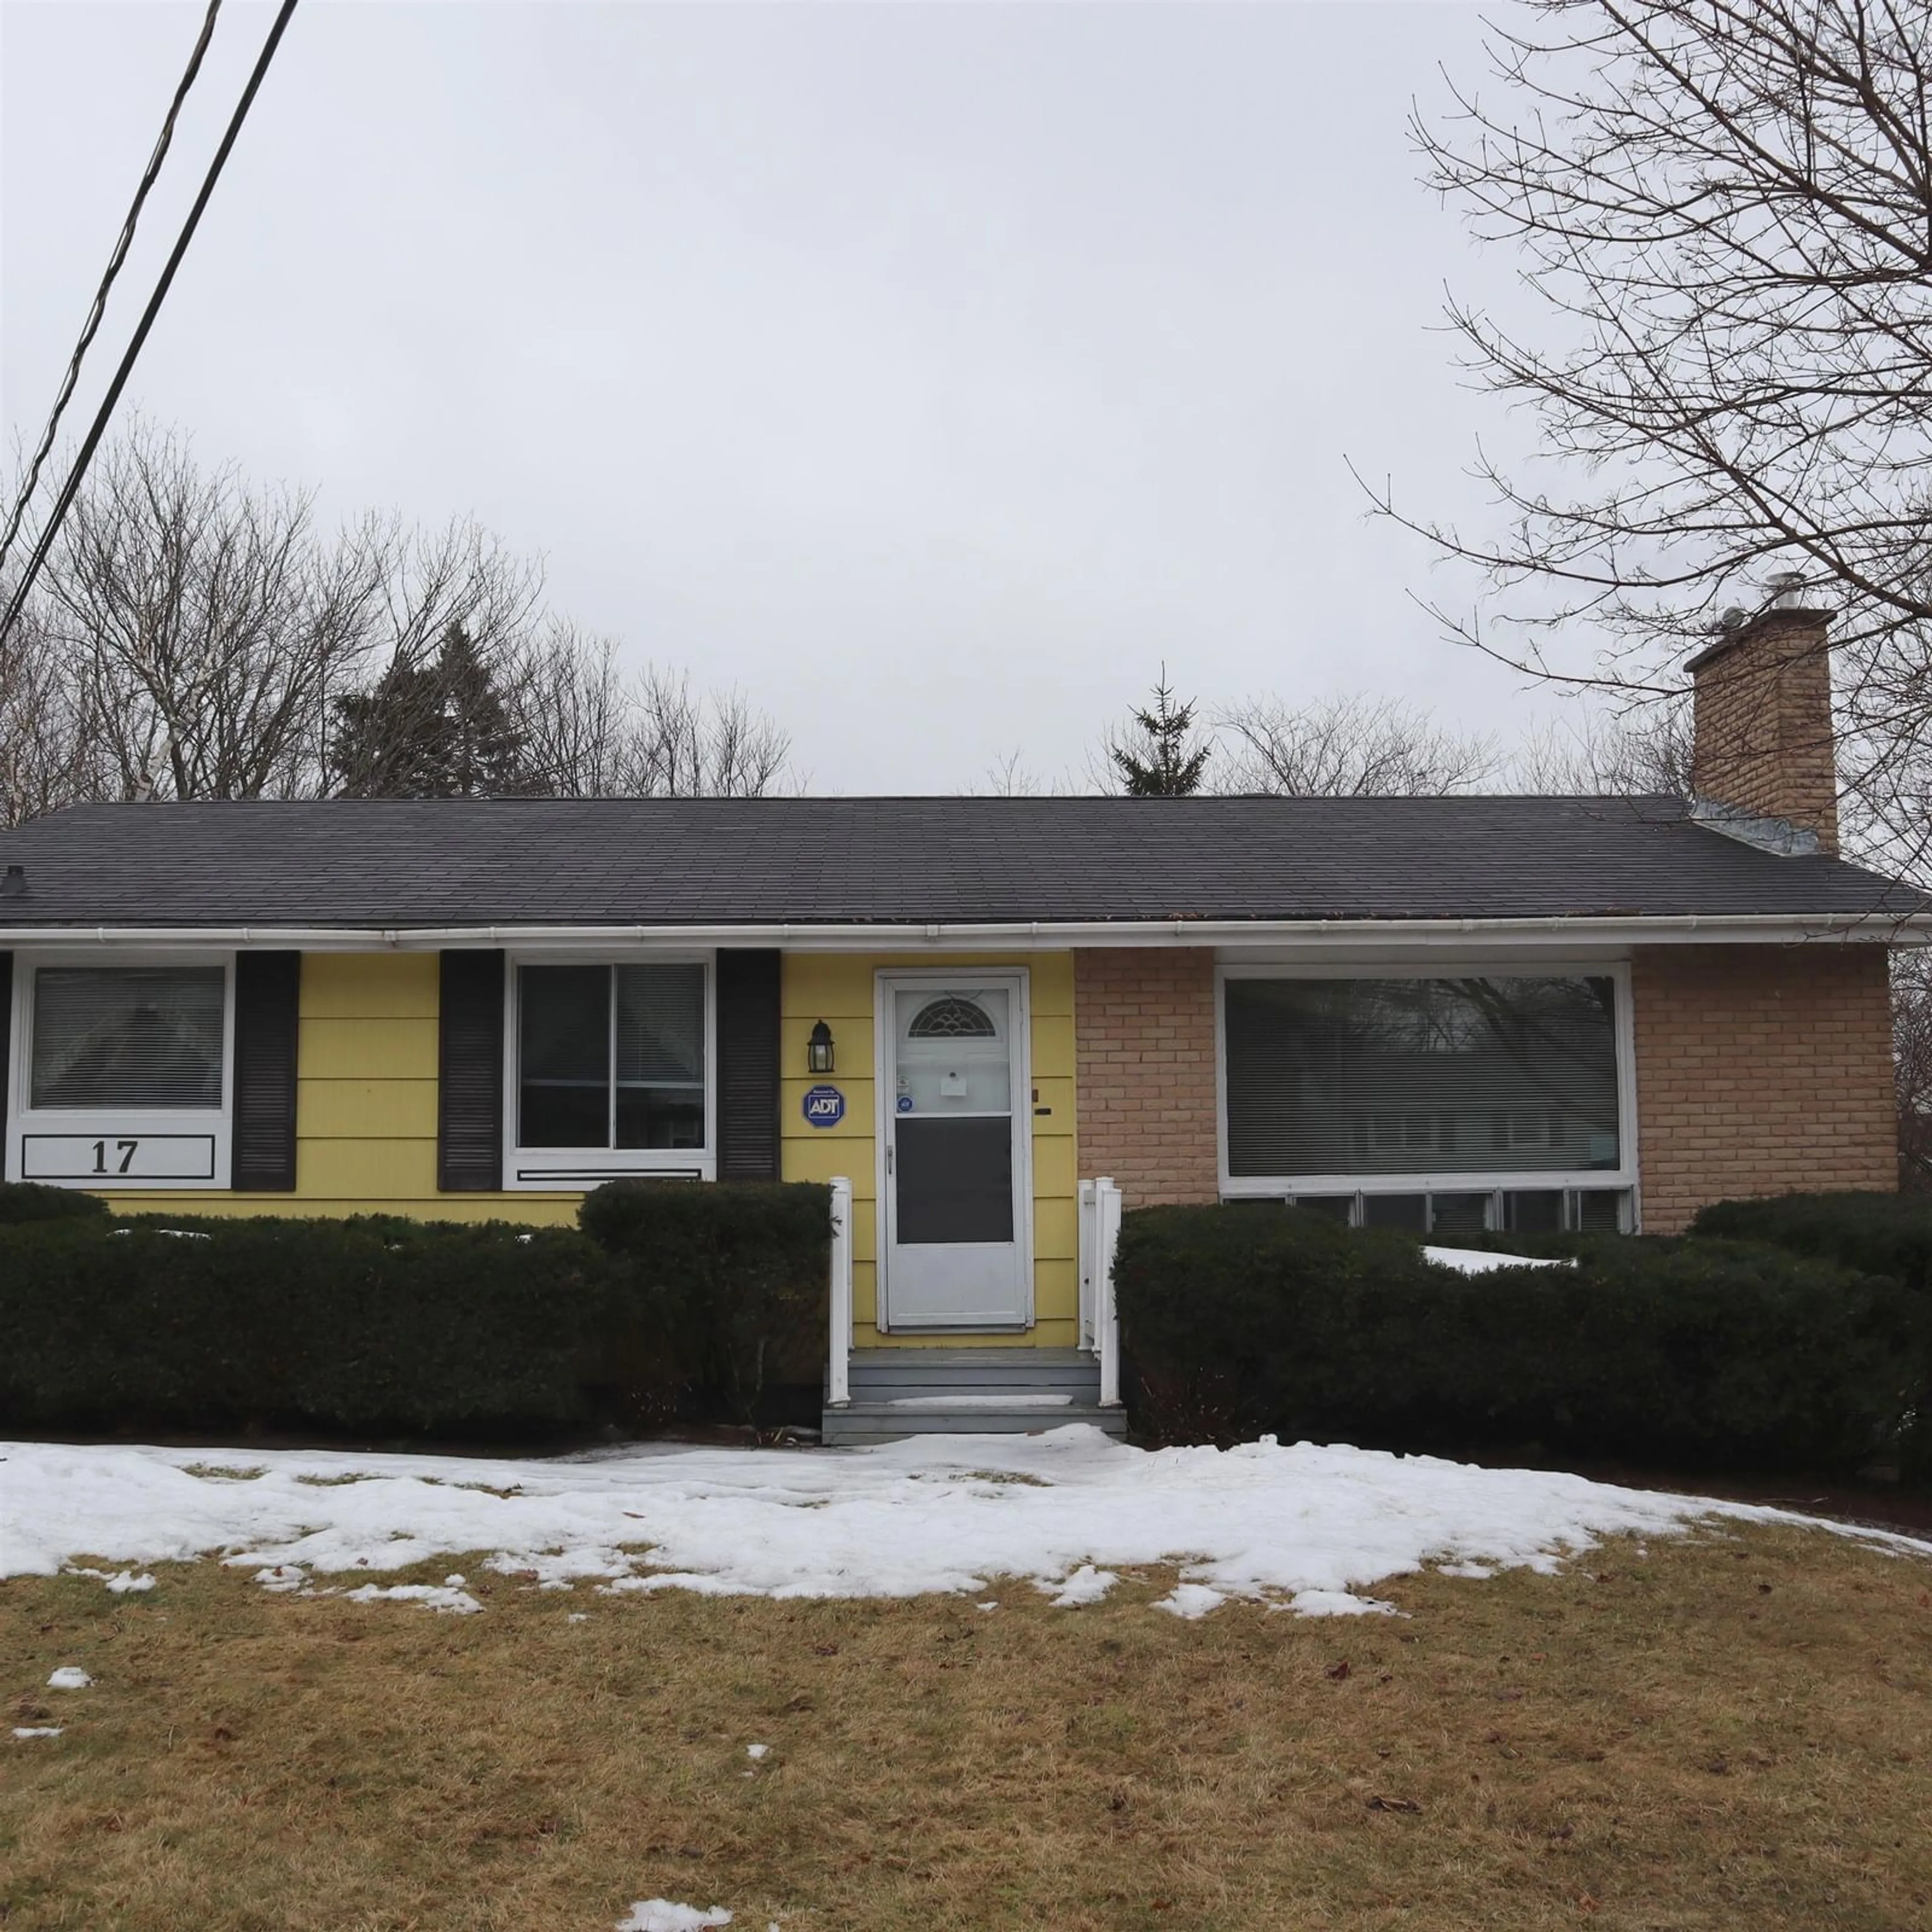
[1117,1205,1928,1470]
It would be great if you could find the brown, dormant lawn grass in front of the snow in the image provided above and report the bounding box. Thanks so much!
[0,1528,1932,1932]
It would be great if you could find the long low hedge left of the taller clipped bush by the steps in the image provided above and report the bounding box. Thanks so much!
[0,1217,609,1435]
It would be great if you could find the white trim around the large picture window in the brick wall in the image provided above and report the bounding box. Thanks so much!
[1214,956,1642,1227]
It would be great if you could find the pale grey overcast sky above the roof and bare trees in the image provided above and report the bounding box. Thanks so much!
[0,0,1548,792]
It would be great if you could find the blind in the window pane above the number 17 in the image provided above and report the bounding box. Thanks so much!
[29,966,228,1107]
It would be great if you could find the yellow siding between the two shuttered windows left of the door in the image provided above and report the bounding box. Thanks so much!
[108,952,584,1225]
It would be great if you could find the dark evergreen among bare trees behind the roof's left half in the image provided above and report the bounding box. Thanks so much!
[329,624,527,798]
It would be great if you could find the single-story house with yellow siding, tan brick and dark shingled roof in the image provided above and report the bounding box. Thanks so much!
[0,605,1932,1420]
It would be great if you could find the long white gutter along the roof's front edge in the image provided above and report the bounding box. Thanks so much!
[0,912,1932,952]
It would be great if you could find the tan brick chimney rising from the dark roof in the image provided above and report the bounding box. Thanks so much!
[1686,578,1837,854]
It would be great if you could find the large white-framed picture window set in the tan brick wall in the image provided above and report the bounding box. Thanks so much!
[1215,960,1636,1235]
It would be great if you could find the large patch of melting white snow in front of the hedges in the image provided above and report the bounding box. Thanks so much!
[0,1426,1932,1615]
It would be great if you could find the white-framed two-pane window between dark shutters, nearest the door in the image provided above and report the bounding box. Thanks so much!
[504,954,717,1188]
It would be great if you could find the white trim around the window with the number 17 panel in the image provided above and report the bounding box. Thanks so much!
[6,947,235,1194]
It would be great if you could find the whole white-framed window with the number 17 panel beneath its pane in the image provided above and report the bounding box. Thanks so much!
[6,950,234,1188]
